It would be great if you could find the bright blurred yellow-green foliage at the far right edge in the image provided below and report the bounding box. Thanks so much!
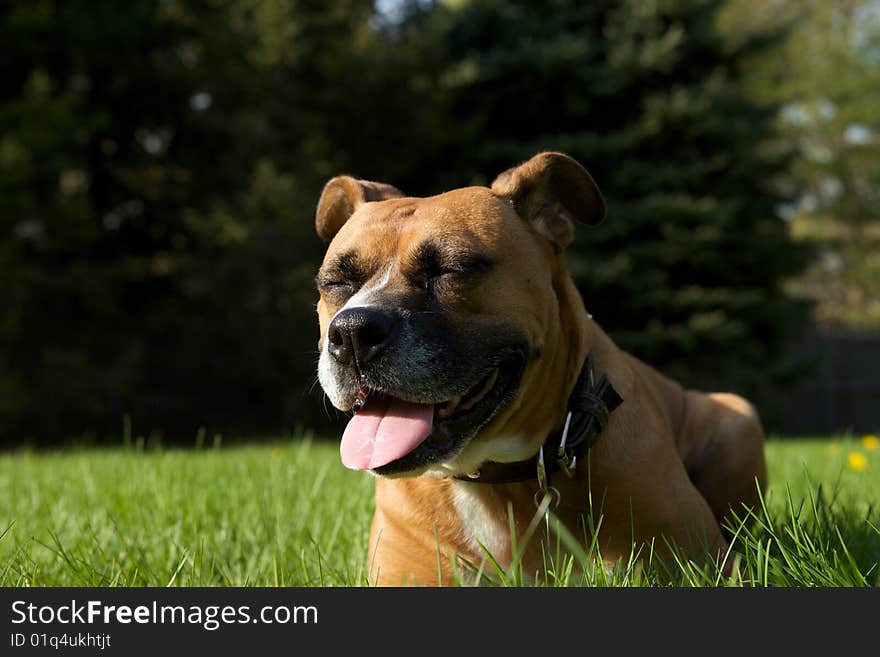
[721,0,880,328]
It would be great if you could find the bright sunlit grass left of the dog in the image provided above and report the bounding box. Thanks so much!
[0,441,372,586]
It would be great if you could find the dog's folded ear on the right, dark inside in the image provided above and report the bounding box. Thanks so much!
[492,153,605,250]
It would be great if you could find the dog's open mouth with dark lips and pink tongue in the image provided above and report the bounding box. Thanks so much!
[340,358,522,475]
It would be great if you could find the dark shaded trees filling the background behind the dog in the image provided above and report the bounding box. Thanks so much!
[0,0,802,443]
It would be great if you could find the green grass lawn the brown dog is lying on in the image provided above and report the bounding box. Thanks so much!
[0,438,880,586]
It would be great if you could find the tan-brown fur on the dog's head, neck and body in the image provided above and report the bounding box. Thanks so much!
[318,154,766,585]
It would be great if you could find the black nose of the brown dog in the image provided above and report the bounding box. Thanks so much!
[327,307,399,368]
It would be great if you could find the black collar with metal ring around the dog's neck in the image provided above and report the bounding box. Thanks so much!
[456,354,623,487]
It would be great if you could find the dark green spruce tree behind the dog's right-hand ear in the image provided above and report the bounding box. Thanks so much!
[412,0,805,420]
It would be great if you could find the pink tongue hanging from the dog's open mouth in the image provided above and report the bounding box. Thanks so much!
[339,397,434,470]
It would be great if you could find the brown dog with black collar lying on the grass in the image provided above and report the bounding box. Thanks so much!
[316,153,766,585]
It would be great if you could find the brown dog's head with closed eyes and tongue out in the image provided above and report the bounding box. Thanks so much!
[316,153,605,476]
